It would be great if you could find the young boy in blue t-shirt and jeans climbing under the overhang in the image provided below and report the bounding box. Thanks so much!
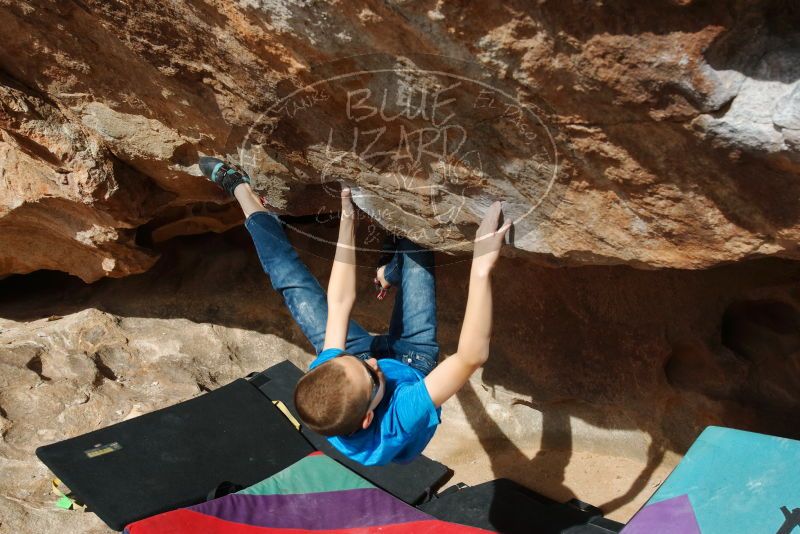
[200,157,511,465]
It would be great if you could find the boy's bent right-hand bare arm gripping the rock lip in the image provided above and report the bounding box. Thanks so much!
[425,202,511,408]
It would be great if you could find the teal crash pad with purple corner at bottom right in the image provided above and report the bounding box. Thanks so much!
[622,426,800,534]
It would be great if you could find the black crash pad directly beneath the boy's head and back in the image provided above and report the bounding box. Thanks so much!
[250,361,453,504]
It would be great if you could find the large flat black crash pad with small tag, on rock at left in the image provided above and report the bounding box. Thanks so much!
[36,379,314,530]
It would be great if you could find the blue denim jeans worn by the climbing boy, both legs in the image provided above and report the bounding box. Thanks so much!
[244,211,439,375]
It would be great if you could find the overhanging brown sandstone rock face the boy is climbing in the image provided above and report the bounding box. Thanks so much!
[0,0,800,281]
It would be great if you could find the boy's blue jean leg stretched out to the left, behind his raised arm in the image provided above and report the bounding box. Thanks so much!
[244,211,378,355]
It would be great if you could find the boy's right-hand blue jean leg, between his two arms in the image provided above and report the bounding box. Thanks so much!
[388,238,439,374]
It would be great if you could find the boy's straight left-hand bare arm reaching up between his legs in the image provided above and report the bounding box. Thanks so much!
[322,186,356,350]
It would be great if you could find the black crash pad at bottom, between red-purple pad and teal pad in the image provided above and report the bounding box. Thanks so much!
[418,478,623,534]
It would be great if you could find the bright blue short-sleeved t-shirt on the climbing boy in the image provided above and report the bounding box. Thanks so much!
[309,349,442,465]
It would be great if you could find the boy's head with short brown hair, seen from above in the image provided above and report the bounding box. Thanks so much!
[294,354,386,436]
